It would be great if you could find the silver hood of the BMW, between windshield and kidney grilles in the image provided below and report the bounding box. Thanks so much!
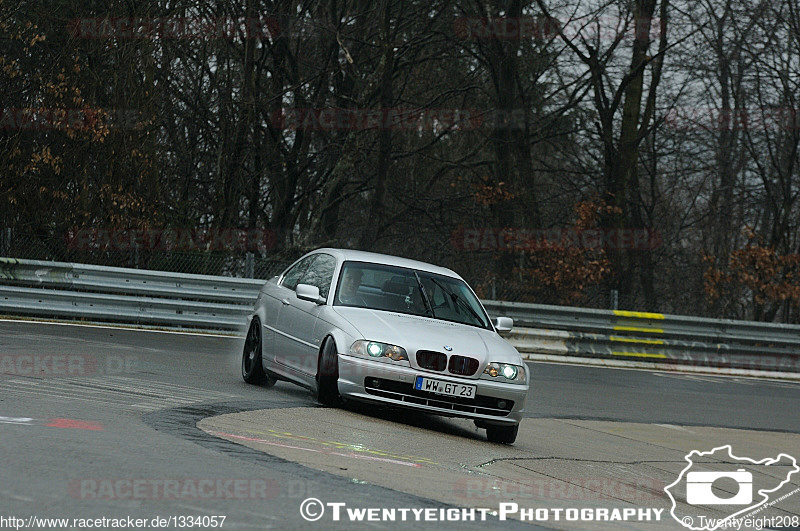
[335,306,523,377]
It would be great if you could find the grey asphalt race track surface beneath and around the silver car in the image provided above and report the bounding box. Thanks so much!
[0,321,800,529]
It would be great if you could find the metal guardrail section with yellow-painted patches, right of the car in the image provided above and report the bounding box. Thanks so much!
[483,301,800,374]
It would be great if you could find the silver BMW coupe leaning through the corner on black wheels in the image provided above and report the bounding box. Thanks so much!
[242,249,530,444]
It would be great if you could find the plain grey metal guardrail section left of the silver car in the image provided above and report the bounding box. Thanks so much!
[0,258,264,332]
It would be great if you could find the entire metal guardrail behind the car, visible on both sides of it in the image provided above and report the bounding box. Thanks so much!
[0,258,800,374]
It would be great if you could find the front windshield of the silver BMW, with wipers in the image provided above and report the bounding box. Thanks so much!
[334,262,491,330]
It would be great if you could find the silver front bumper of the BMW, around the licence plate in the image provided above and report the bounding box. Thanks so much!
[338,353,528,425]
